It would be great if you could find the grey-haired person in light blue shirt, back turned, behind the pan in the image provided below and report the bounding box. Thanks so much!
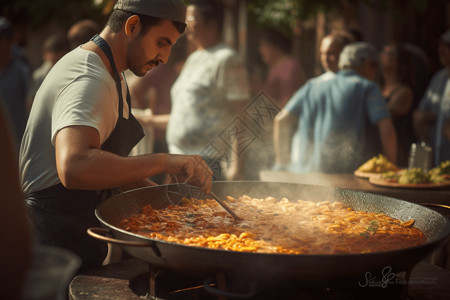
[274,42,397,173]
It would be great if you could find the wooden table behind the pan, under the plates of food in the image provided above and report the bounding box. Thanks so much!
[260,170,450,206]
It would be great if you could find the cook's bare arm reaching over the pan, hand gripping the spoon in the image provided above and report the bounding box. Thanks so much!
[55,126,212,191]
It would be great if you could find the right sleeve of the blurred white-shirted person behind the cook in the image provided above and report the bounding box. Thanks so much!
[217,54,250,101]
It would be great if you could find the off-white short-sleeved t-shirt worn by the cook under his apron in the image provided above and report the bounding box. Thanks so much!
[19,47,128,194]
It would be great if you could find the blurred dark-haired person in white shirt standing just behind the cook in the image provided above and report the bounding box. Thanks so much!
[167,0,250,180]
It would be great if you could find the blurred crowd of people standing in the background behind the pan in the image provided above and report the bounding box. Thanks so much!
[0,0,450,298]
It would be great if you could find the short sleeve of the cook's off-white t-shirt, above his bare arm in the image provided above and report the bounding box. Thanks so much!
[52,76,111,144]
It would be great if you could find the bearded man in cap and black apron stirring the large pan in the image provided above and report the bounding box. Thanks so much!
[20,0,212,269]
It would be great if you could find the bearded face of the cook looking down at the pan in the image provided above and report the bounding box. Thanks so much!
[127,20,180,77]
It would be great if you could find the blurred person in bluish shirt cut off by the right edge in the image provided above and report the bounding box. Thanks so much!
[413,30,450,166]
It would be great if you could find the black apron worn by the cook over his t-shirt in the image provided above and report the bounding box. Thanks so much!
[26,35,144,271]
